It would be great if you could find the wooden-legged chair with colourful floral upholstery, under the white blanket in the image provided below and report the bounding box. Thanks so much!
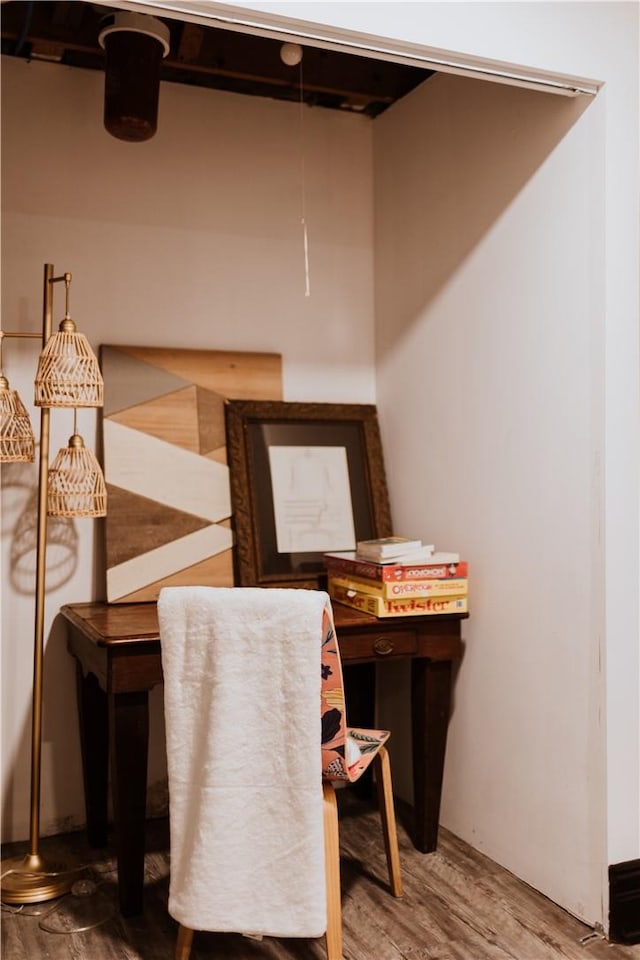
[165,598,402,960]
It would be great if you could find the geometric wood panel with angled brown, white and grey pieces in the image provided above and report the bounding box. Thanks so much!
[100,345,282,603]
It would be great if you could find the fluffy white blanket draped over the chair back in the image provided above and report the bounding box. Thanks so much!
[158,587,328,937]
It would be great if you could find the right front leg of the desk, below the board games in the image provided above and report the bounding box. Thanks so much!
[411,658,451,853]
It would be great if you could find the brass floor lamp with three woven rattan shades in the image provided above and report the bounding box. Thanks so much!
[0,263,107,903]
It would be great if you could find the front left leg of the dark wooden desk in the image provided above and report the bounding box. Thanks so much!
[110,691,149,917]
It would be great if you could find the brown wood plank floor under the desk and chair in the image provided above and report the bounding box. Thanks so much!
[2,791,640,960]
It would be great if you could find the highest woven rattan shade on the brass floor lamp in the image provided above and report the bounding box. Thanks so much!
[35,317,104,407]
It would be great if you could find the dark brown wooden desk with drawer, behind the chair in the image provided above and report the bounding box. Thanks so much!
[61,603,463,916]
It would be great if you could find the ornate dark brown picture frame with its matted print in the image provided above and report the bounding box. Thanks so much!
[225,400,391,588]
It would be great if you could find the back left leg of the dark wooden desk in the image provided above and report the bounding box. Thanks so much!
[76,660,109,847]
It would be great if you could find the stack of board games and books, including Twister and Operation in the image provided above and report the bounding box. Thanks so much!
[324,537,469,617]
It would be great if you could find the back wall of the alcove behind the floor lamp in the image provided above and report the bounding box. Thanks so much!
[2,58,374,839]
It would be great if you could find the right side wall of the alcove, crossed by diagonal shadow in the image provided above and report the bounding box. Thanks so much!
[374,67,605,921]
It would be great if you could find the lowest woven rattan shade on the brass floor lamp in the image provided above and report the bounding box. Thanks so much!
[47,433,107,517]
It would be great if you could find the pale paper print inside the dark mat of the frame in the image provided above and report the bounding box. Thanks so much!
[269,447,356,553]
